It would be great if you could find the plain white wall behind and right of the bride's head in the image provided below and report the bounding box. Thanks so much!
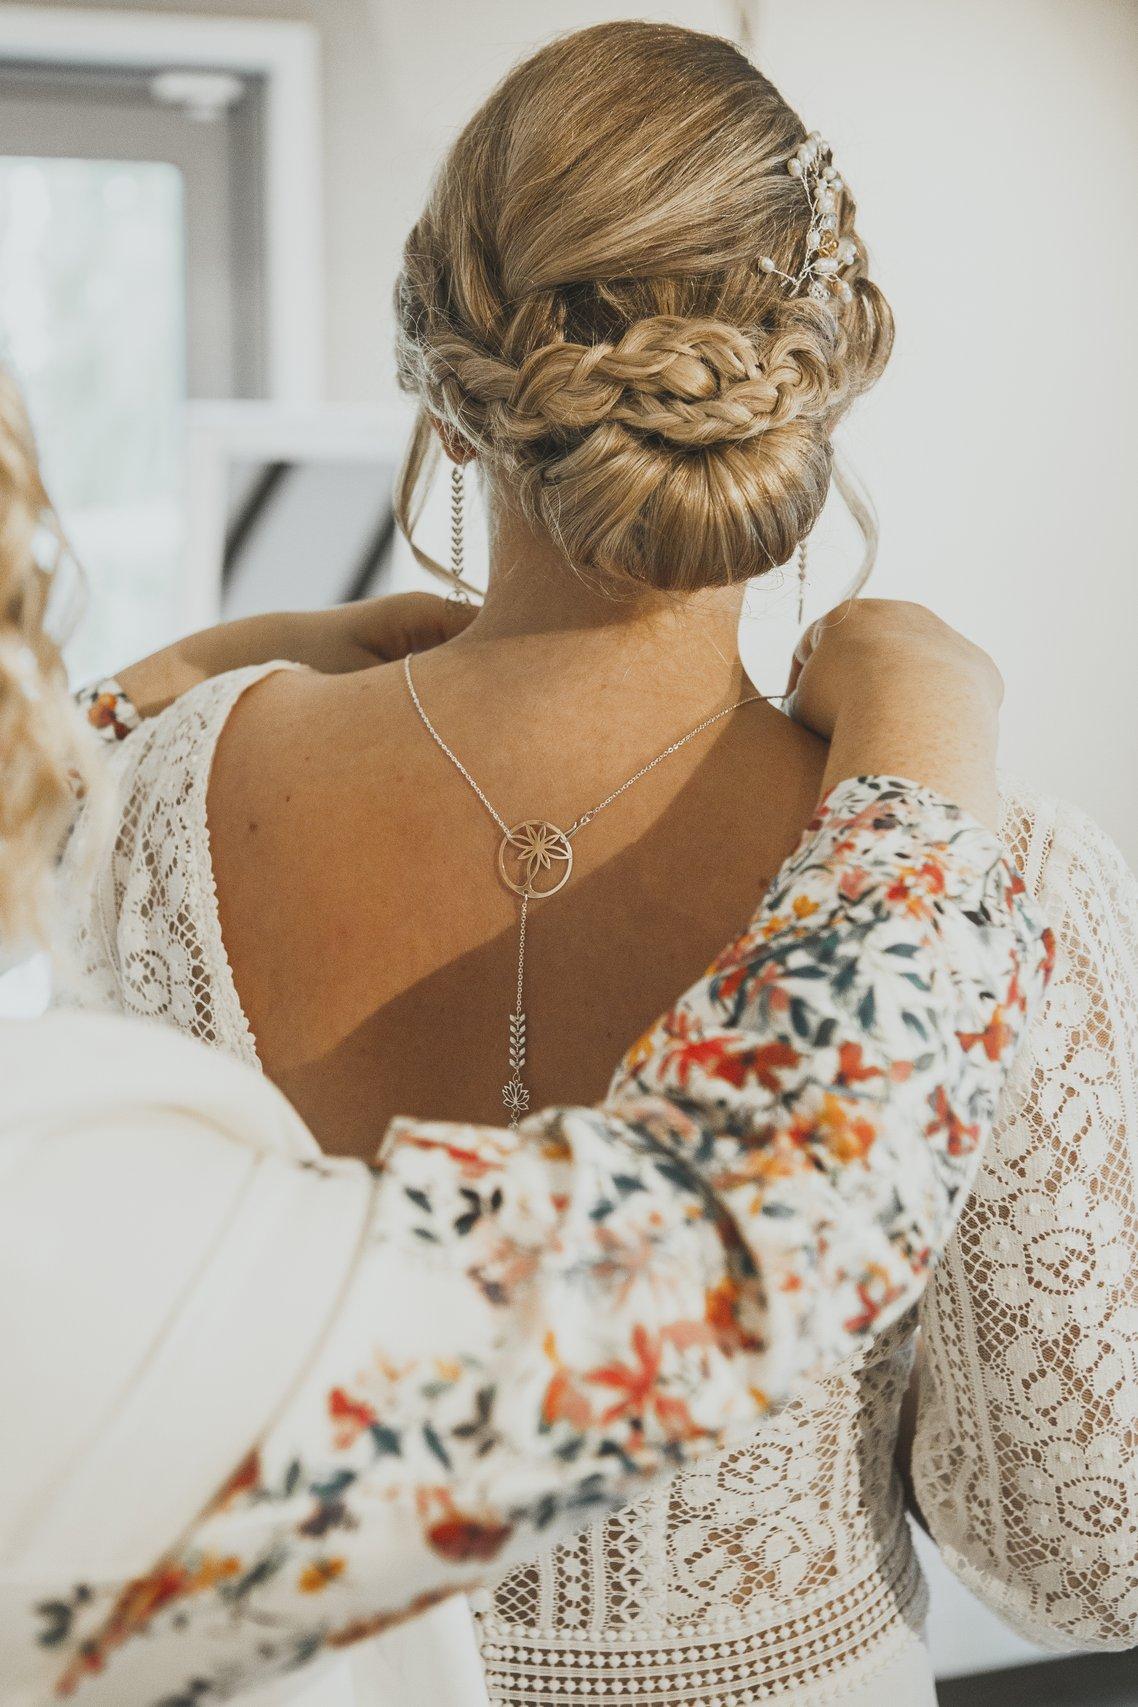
[26,0,1138,864]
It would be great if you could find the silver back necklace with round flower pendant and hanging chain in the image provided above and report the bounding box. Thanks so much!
[403,654,766,1127]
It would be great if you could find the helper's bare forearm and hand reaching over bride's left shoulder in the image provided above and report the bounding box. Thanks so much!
[118,592,476,717]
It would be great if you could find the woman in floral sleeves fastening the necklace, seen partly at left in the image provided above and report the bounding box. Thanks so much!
[0,379,1048,1707]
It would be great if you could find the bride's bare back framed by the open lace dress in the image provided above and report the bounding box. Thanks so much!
[208,647,826,1157]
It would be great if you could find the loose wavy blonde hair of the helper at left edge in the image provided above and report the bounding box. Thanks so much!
[0,369,96,944]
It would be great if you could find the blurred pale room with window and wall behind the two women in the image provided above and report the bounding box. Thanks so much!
[0,0,1138,1707]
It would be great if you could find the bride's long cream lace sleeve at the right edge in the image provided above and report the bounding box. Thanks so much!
[913,801,1138,1649]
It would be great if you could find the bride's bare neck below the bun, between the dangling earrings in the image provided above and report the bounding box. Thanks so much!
[445,488,747,715]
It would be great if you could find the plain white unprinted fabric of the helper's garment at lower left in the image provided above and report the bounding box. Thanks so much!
[0,1014,486,1707]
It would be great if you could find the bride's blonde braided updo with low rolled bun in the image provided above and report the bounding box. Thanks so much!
[396,22,892,592]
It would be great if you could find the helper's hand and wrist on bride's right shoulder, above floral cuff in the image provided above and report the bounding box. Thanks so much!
[787,599,1003,828]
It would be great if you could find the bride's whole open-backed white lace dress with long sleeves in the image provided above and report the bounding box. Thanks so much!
[63,666,1138,1707]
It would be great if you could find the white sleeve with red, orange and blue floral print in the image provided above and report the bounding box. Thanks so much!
[42,778,1051,1707]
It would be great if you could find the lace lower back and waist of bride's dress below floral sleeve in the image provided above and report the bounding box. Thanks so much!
[479,1316,925,1707]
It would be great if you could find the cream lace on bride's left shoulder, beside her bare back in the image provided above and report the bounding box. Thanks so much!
[55,664,296,1067]
